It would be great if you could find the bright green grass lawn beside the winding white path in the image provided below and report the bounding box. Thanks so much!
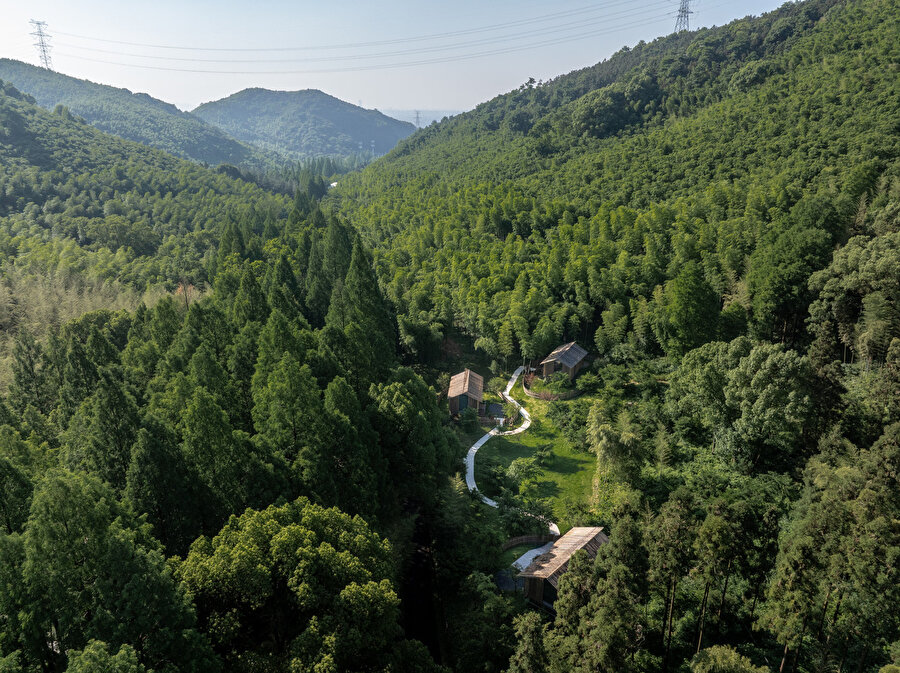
[475,382,596,532]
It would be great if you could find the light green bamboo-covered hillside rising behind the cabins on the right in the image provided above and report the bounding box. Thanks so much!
[329,0,900,357]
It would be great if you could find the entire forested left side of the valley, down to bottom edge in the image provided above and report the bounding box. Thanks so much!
[0,76,460,673]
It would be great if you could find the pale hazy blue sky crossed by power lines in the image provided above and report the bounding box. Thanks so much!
[0,0,781,110]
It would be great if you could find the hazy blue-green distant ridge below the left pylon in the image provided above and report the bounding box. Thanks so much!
[0,58,269,168]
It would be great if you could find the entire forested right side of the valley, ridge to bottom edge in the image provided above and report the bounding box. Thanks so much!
[326,0,900,673]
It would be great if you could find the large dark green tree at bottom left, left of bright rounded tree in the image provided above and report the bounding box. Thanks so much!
[18,470,217,673]
